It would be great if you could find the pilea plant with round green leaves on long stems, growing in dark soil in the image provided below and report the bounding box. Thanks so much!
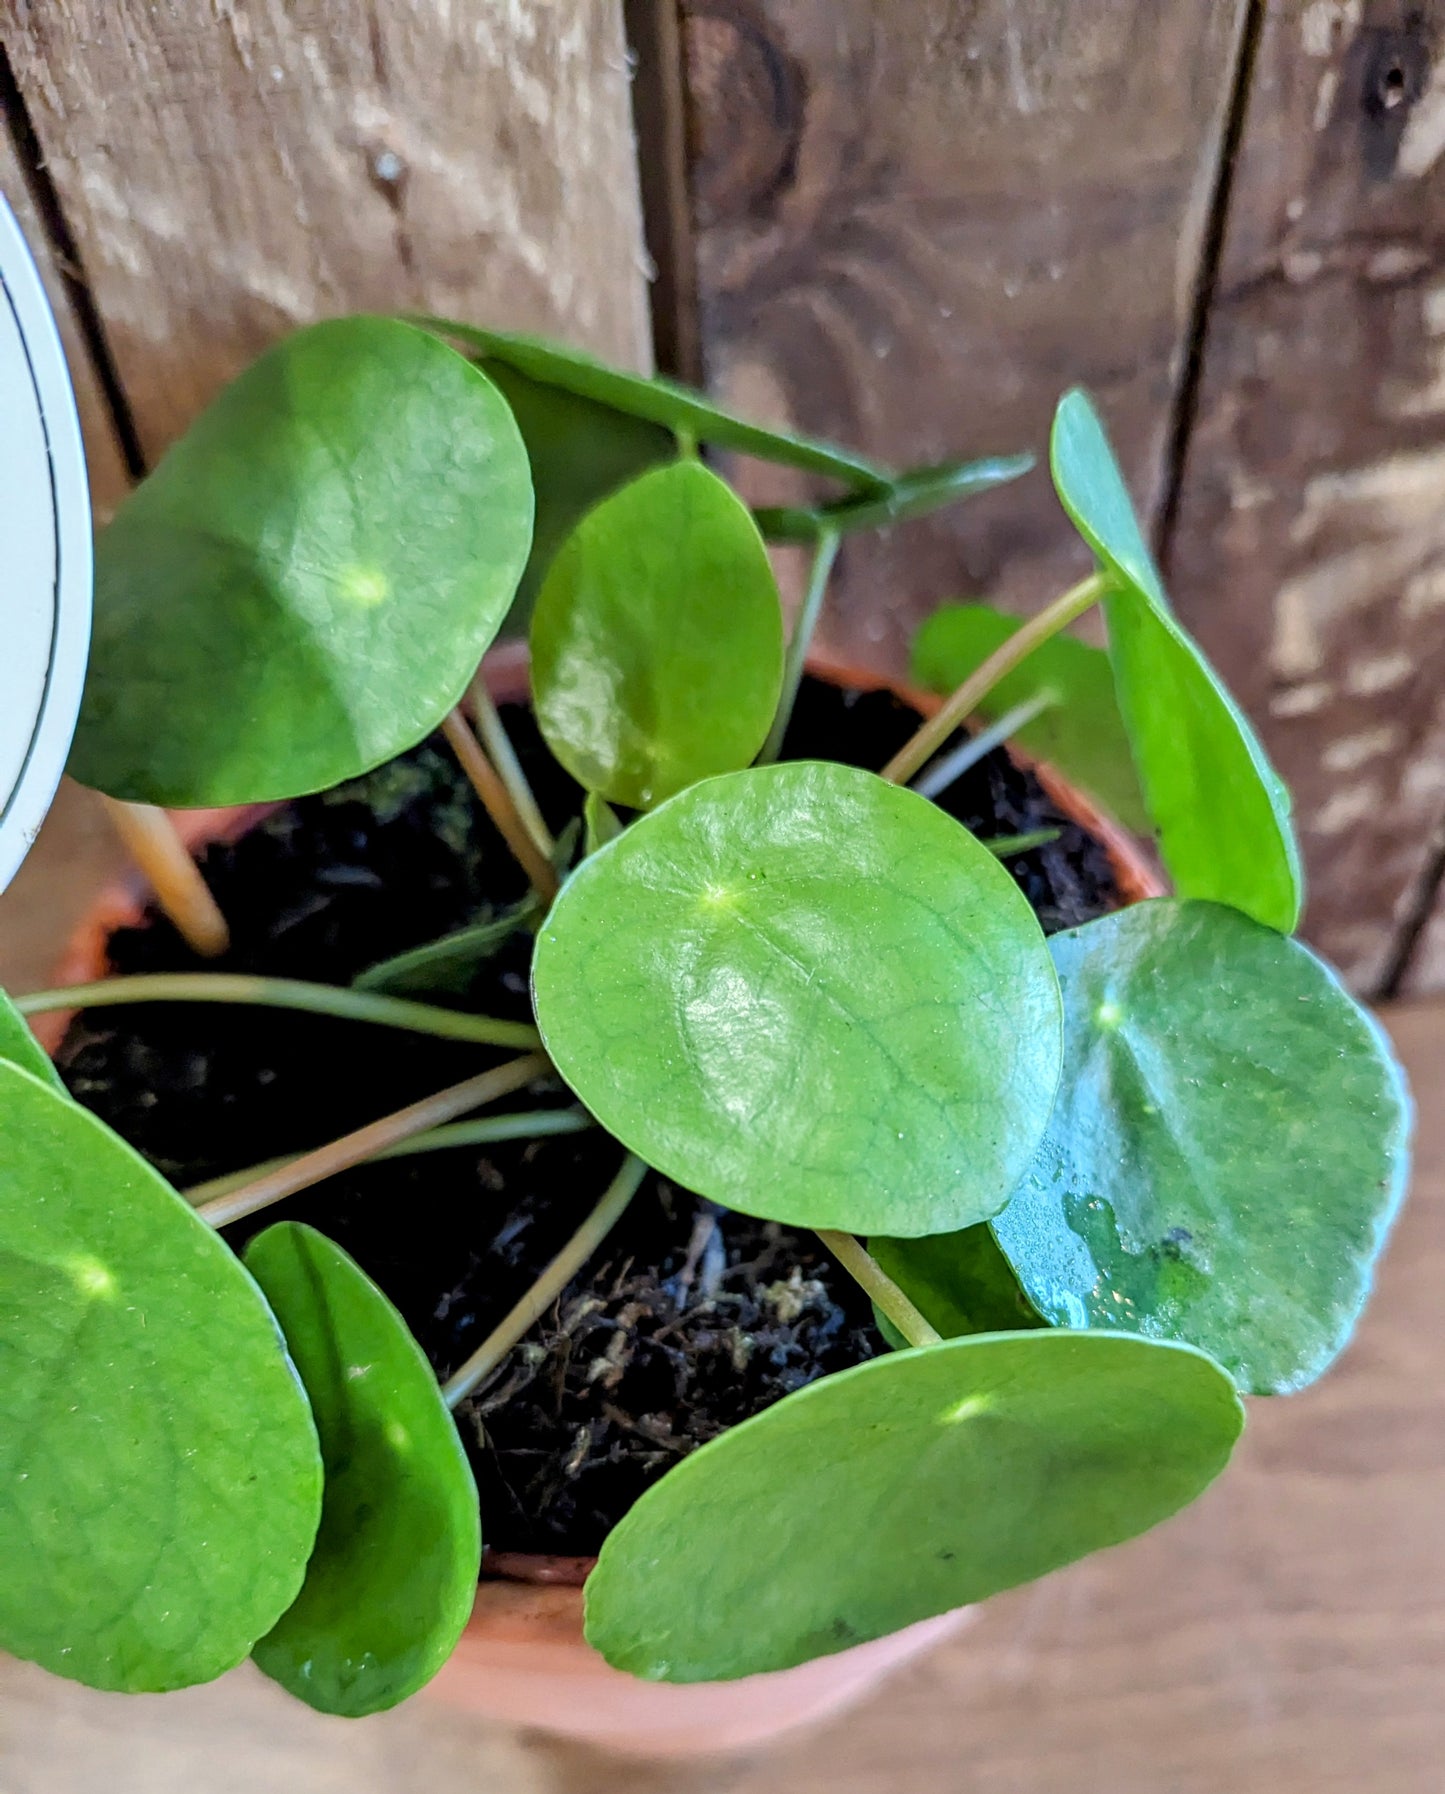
[0,318,1409,1750]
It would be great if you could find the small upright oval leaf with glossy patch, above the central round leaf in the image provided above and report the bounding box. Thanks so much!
[531,461,783,809]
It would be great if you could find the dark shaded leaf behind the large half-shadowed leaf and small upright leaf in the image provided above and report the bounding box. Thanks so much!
[479,355,677,633]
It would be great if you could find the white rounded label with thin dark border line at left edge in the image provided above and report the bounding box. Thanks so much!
[0,197,92,890]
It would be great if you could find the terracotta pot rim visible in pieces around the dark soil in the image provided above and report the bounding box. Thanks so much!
[45,642,1167,1589]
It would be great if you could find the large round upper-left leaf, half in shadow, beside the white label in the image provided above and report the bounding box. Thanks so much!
[70,318,531,806]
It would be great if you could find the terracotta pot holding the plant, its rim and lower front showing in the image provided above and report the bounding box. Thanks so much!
[36,644,1165,1756]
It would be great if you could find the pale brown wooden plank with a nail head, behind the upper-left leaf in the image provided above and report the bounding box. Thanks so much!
[0,0,648,459]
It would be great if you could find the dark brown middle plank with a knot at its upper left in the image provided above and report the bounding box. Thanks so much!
[684,0,1244,669]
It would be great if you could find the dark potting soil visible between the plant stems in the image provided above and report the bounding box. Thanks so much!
[59,680,1118,1555]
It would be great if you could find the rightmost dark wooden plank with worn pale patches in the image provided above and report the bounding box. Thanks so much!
[1167,0,1445,990]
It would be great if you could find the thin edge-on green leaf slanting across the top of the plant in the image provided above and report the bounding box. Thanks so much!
[416,318,892,492]
